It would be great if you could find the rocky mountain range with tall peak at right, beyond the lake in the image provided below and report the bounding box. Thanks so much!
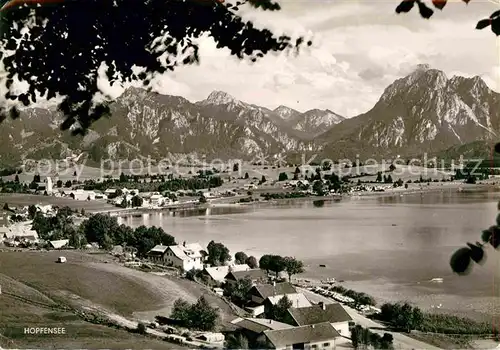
[0,65,500,165]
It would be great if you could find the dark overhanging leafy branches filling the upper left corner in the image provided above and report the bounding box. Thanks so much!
[1,0,311,134]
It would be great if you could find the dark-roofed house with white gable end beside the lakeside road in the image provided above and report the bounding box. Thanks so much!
[287,303,352,337]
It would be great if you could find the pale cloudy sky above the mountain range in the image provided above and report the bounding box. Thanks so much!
[137,0,500,117]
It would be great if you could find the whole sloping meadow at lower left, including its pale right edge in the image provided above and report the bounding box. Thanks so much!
[0,251,235,349]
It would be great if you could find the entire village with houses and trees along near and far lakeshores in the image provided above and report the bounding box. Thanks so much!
[0,163,492,349]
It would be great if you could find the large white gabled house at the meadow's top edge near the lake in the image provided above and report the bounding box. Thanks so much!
[148,242,203,271]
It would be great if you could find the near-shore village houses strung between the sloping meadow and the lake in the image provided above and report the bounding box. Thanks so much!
[2,223,392,349]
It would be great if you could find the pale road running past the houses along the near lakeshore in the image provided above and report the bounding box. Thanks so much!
[297,288,440,350]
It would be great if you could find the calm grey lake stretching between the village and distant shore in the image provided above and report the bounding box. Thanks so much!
[120,190,500,320]
